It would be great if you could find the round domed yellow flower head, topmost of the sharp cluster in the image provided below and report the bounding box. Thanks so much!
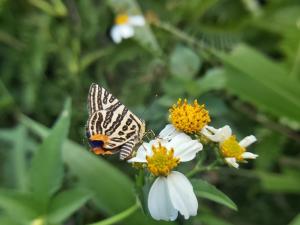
[169,99,210,133]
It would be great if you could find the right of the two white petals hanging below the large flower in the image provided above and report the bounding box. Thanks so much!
[167,171,198,219]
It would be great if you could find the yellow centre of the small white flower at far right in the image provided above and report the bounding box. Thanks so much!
[220,135,246,161]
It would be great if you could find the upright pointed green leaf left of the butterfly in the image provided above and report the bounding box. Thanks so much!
[30,100,70,207]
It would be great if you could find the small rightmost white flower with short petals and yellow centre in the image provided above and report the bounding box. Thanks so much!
[201,125,258,168]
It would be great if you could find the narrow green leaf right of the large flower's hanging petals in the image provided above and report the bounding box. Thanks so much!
[192,179,237,210]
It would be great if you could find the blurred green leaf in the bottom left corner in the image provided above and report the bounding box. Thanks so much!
[0,189,39,222]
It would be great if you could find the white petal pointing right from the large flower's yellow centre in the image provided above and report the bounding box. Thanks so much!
[173,140,203,162]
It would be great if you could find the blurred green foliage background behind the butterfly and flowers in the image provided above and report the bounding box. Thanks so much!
[0,0,300,225]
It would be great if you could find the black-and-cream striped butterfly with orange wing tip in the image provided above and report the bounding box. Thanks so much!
[86,83,145,160]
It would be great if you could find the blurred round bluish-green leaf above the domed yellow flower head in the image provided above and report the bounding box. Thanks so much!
[169,45,201,79]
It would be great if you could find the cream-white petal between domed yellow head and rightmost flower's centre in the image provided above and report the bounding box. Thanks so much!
[201,125,232,142]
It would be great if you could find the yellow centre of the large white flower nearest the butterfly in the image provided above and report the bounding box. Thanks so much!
[146,143,179,176]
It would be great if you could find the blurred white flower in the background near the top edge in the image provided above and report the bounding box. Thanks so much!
[110,14,145,44]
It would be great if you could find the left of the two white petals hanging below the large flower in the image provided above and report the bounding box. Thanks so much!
[148,177,178,221]
